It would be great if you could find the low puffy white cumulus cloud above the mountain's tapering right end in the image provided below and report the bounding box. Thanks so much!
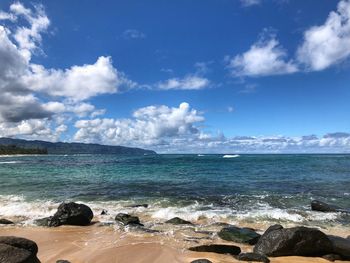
[74,102,204,146]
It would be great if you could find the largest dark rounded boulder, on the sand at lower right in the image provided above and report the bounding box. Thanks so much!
[254,227,333,257]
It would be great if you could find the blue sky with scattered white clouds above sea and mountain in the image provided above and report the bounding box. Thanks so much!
[0,0,350,153]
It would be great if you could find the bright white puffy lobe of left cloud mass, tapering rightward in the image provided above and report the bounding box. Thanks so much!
[23,57,136,101]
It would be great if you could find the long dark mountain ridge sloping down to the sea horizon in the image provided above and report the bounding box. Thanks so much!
[0,138,156,155]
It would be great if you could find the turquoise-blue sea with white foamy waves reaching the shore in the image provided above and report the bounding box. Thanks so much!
[0,155,350,227]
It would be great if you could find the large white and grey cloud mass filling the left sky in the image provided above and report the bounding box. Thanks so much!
[0,2,136,140]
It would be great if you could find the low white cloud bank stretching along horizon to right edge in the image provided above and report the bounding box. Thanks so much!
[74,102,350,153]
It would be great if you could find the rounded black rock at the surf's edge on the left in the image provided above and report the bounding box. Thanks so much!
[49,202,94,226]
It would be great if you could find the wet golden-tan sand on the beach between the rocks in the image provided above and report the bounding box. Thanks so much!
[0,224,350,263]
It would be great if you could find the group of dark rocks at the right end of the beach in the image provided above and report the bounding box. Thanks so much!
[189,201,350,263]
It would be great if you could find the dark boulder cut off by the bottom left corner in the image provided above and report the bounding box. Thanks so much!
[0,236,40,263]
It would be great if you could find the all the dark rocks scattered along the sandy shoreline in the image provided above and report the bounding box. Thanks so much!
[0,201,350,263]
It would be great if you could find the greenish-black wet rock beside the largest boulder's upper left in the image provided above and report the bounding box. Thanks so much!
[218,226,260,245]
